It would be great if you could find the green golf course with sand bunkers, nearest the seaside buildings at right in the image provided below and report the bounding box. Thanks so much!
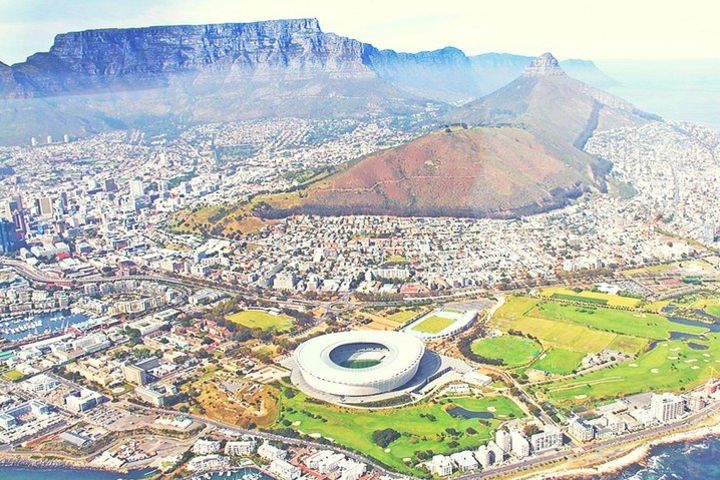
[535,334,720,408]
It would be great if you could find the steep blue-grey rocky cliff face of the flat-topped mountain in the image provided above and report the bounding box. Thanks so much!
[12,19,373,96]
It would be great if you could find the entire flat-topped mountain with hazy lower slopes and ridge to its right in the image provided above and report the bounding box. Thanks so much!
[0,18,620,143]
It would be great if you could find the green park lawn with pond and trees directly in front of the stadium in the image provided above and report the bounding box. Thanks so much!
[275,393,522,473]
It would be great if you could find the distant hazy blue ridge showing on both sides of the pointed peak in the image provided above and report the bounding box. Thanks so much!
[469,53,618,95]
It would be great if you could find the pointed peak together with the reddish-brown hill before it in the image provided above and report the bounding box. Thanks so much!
[256,53,654,218]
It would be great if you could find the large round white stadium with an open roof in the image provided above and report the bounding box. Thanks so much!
[293,330,441,403]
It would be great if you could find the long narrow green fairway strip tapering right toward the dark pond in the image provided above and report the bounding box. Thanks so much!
[529,302,708,340]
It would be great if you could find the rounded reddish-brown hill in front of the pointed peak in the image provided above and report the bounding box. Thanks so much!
[256,128,603,218]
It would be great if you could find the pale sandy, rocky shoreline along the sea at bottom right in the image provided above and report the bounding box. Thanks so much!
[526,416,720,480]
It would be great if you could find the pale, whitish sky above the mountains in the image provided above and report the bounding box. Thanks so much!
[0,0,720,64]
